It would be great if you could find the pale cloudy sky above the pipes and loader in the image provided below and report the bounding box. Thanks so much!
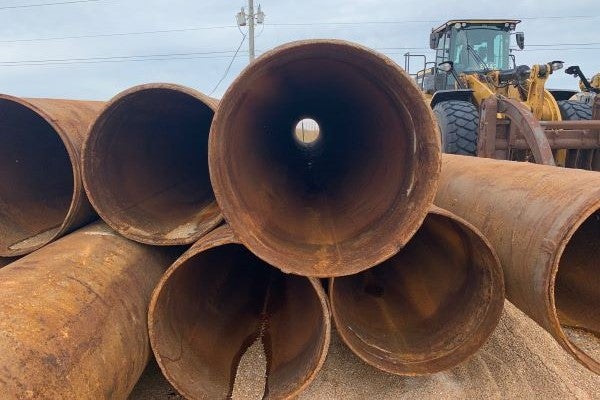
[0,0,600,100]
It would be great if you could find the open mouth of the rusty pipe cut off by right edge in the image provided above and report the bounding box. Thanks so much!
[554,210,600,363]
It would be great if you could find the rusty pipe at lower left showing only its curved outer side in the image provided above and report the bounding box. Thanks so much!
[0,223,178,399]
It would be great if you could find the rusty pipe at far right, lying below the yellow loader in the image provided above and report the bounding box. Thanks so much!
[436,155,600,373]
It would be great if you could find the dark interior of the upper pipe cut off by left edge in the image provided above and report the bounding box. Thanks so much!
[0,99,74,254]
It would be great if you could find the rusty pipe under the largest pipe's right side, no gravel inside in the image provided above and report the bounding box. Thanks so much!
[329,207,504,375]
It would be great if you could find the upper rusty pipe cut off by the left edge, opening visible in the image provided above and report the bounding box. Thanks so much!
[0,94,103,257]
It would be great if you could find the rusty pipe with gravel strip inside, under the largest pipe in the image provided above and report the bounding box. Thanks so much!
[148,226,331,399]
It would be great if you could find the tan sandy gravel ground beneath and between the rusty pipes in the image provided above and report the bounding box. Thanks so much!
[130,302,600,400]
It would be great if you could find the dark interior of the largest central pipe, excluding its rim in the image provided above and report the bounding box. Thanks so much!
[220,46,422,268]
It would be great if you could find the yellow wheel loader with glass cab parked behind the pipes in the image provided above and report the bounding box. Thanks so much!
[405,19,600,170]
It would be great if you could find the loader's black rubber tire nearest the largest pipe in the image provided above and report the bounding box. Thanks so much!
[433,100,479,156]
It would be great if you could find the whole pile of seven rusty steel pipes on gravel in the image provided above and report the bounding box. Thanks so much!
[0,40,600,399]
